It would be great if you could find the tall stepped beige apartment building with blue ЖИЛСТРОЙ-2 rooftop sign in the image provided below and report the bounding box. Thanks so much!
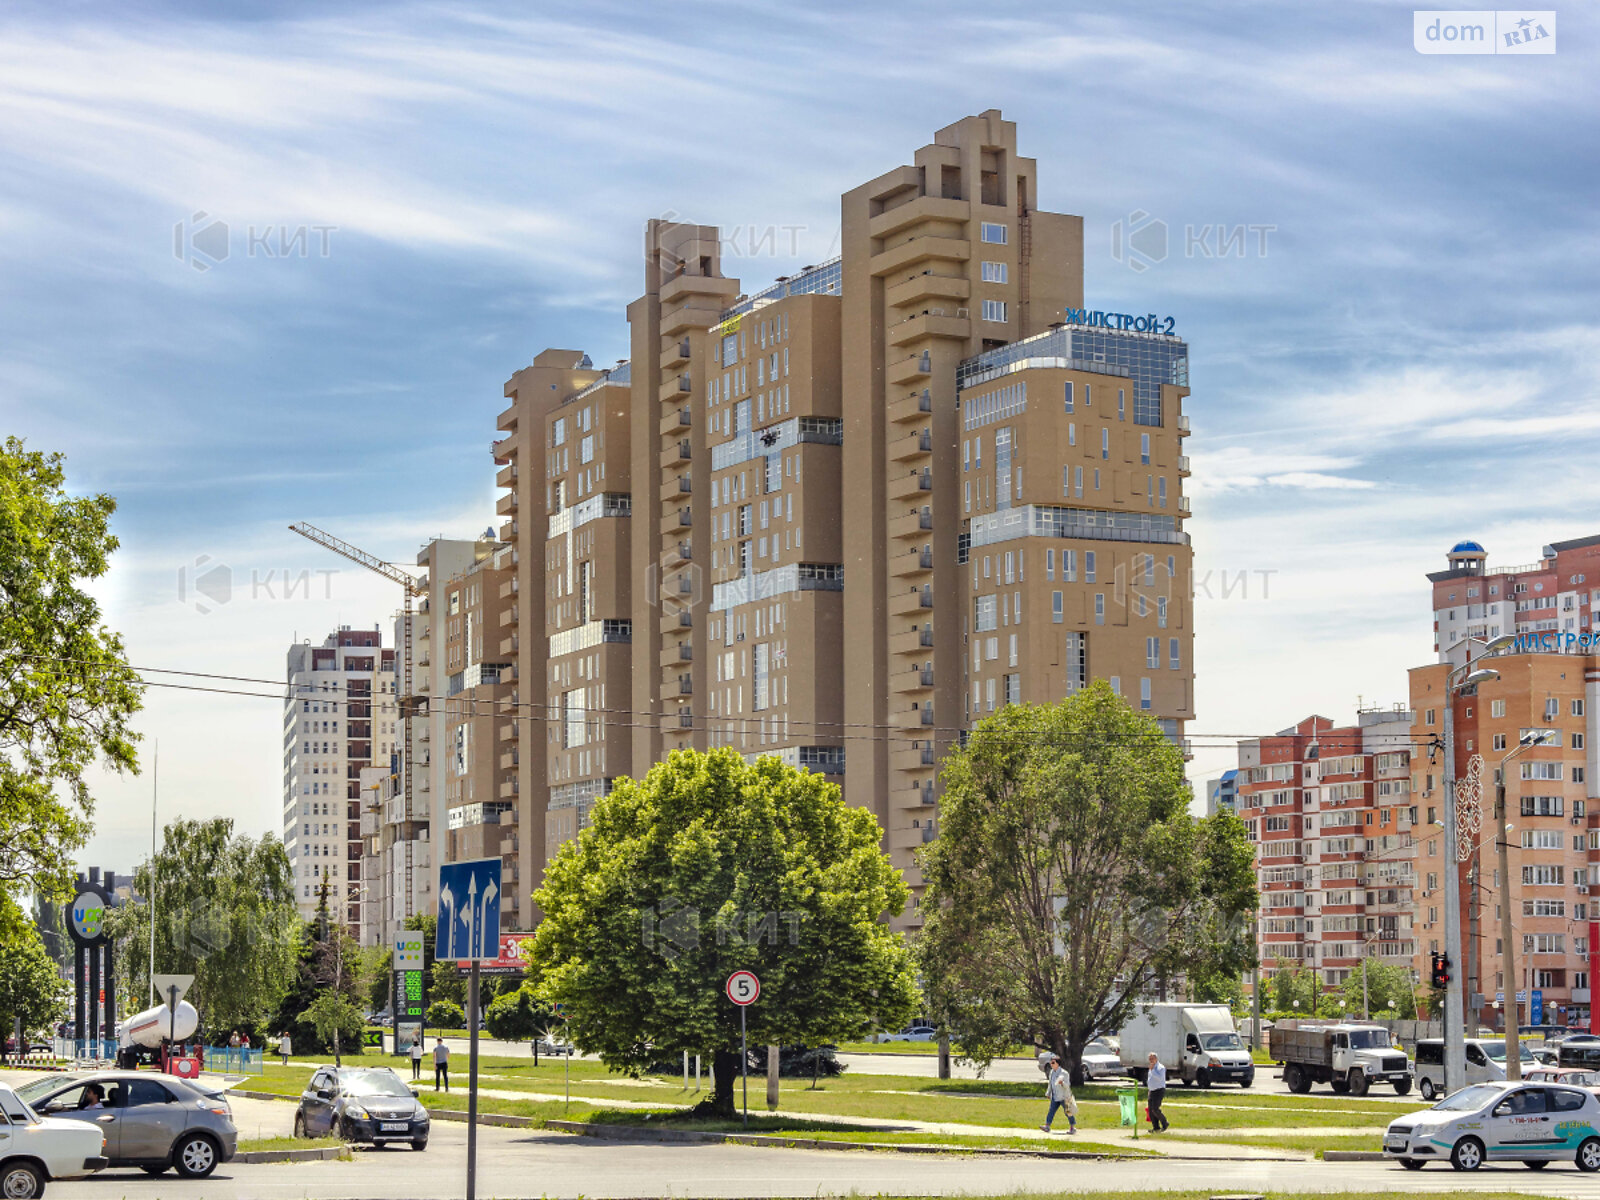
[493,110,1194,922]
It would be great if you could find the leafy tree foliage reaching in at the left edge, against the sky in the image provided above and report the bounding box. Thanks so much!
[0,437,142,936]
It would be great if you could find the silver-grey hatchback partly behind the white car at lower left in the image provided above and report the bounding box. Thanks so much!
[16,1070,238,1179]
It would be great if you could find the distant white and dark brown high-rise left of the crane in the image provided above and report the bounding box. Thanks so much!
[283,626,398,936]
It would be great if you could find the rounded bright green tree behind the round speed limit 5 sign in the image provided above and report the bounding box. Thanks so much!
[530,749,917,1115]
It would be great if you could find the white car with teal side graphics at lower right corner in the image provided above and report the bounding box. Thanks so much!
[1384,1083,1600,1171]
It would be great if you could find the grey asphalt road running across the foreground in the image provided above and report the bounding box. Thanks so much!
[50,1120,1595,1200]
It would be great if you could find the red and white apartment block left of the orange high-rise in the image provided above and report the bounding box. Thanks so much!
[1235,709,1414,987]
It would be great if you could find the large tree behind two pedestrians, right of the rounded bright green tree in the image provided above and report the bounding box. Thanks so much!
[918,682,1256,1078]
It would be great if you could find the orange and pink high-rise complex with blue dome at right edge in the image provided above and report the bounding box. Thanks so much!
[1411,538,1600,1027]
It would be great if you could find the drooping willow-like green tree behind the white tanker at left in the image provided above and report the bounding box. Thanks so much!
[106,818,301,1038]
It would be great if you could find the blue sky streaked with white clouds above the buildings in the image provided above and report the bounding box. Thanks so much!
[0,0,1600,870]
